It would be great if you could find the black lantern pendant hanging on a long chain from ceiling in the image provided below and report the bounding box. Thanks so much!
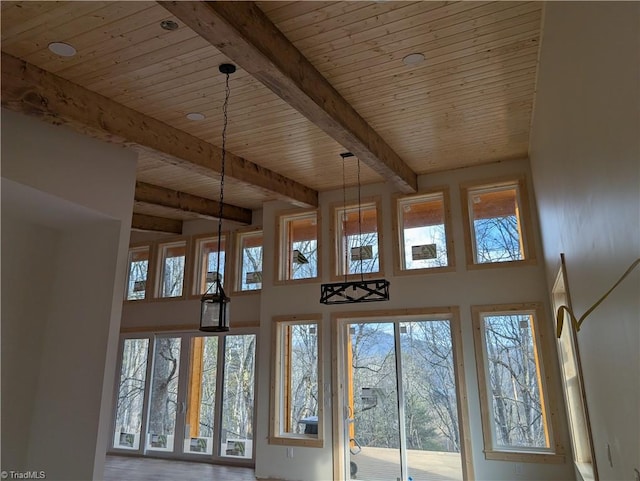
[200,63,236,332]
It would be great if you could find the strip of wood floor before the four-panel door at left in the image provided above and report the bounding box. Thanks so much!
[104,455,256,481]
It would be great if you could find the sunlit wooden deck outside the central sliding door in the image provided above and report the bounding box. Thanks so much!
[351,447,462,481]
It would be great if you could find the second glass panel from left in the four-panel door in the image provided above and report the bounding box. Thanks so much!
[147,337,181,452]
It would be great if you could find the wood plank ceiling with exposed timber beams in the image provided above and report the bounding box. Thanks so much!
[1,1,543,230]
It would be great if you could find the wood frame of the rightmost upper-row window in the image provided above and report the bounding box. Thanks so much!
[460,175,536,269]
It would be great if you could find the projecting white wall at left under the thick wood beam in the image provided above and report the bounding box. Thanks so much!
[2,110,136,481]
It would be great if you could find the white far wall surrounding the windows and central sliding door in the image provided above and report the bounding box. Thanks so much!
[250,160,573,481]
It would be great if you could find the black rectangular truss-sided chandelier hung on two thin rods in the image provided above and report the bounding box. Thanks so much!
[320,152,390,304]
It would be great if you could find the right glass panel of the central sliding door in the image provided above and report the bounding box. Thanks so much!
[400,320,463,481]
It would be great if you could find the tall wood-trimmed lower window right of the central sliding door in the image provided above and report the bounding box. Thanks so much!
[473,304,563,462]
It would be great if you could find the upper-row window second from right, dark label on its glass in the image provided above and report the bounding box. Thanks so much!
[395,192,453,271]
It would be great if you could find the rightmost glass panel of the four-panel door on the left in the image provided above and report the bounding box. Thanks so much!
[220,334,256,459]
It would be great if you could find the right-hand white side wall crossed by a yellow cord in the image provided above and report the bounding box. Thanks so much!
[530,2,640,480]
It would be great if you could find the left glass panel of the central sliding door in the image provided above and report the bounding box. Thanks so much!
[346,322,402,481]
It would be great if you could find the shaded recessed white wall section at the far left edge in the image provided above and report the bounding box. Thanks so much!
[2,215,58,471]
